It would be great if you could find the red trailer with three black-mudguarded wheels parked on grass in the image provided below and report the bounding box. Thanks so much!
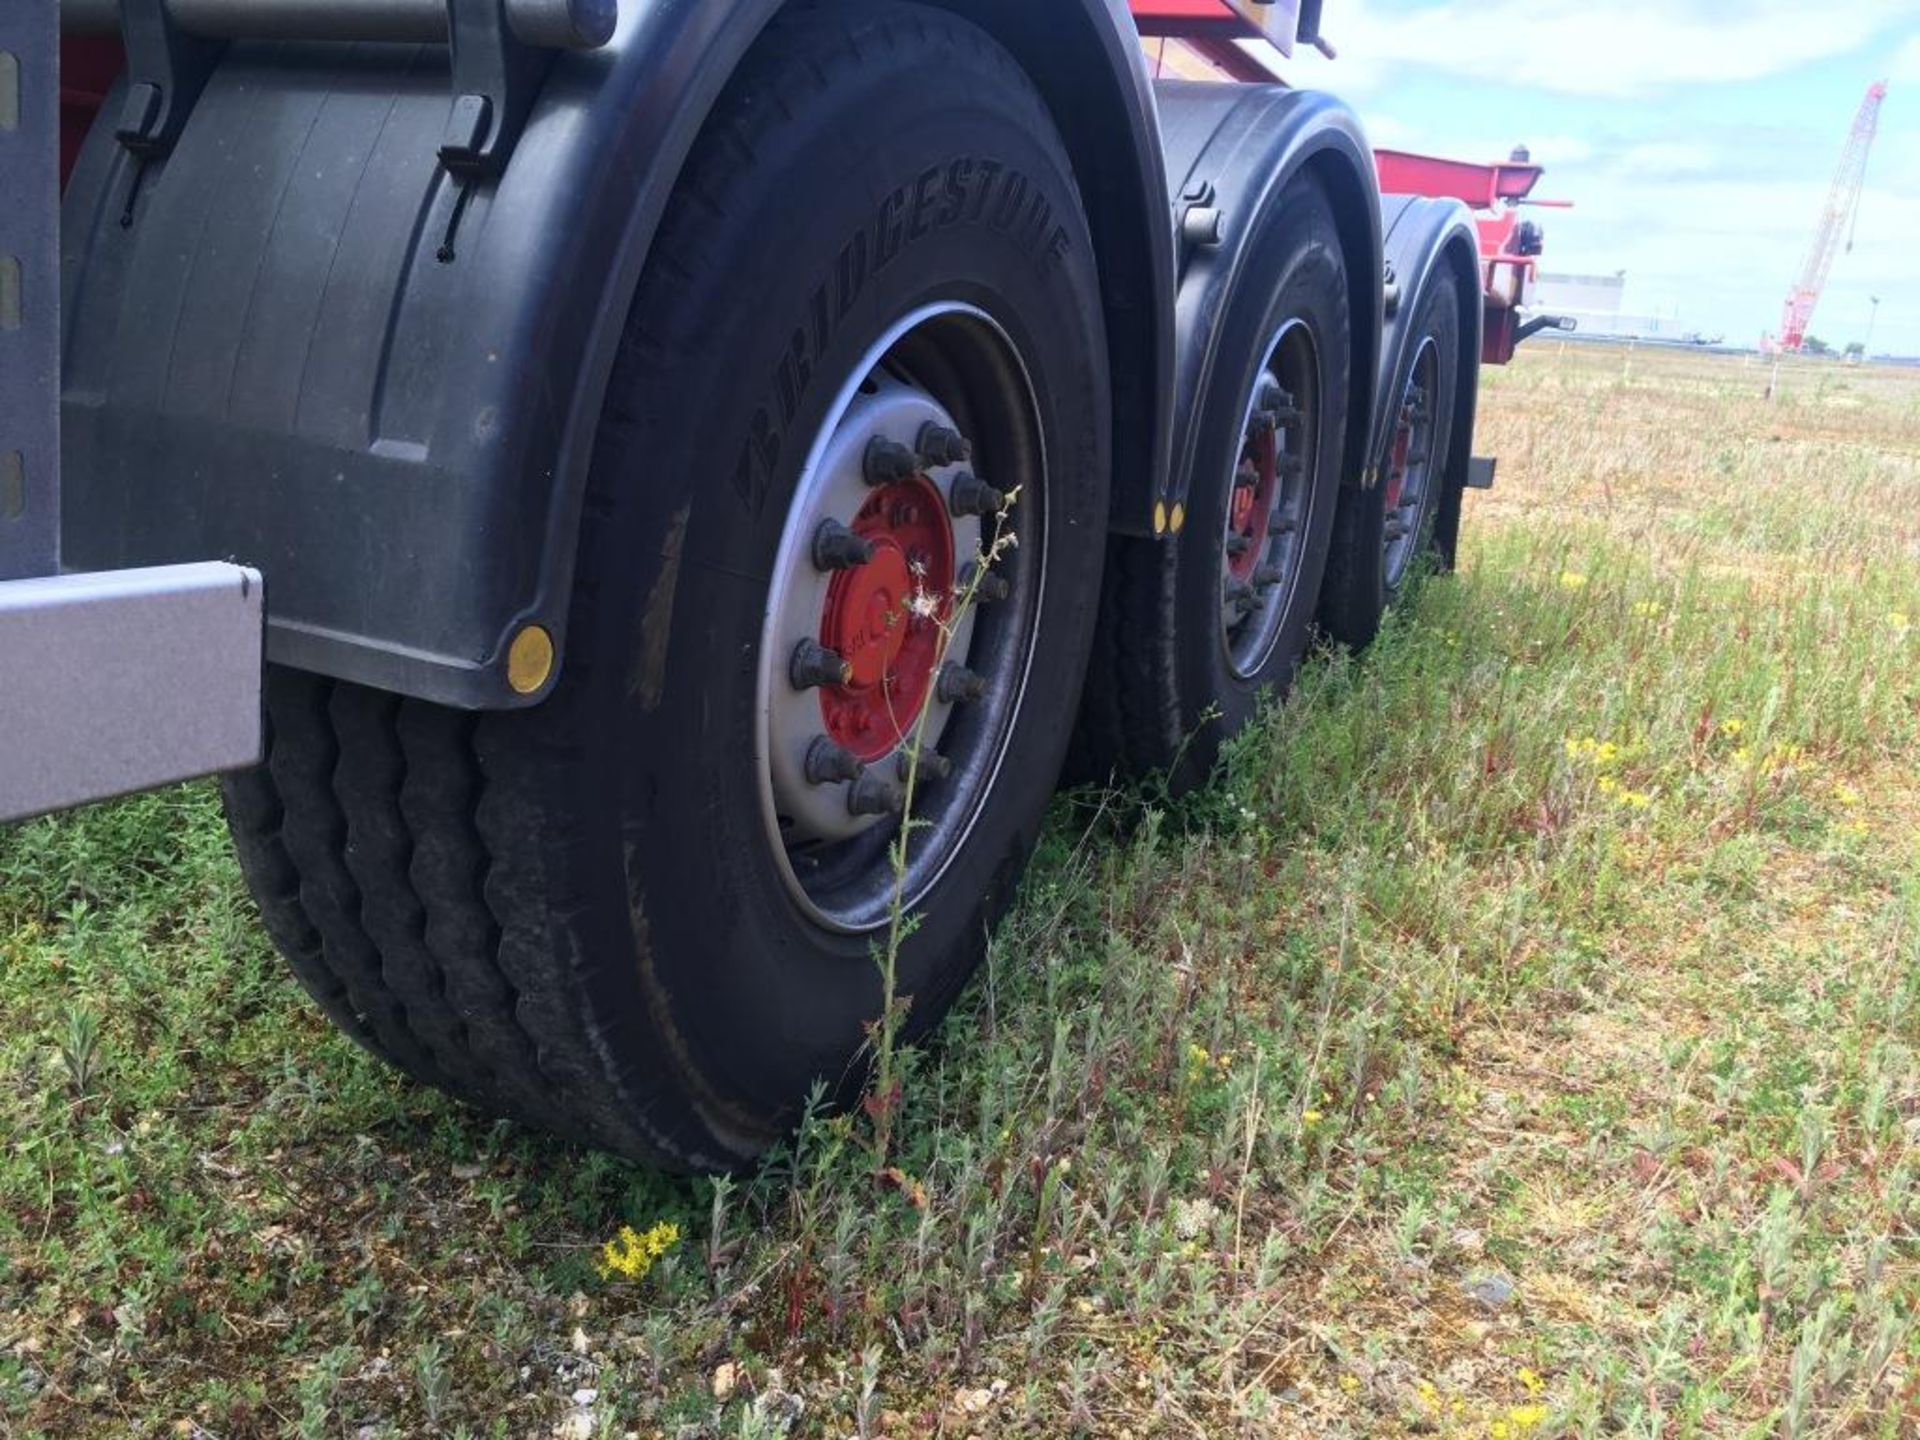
[0,0,1538,1167]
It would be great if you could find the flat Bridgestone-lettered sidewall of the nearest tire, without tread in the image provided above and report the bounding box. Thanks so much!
[555,21,1110,1148]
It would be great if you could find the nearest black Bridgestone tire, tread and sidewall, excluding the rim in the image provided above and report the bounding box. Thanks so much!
[227,2,1112,1169]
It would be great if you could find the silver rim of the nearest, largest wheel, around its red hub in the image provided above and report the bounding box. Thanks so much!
[755,303,1048,935]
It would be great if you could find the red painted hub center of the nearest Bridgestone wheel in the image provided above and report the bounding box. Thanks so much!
[820,476,954,762]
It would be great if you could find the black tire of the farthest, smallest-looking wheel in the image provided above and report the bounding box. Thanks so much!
[1321,269,1461,649]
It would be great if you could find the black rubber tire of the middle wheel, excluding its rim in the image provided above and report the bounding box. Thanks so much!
[1077,175,1354,793]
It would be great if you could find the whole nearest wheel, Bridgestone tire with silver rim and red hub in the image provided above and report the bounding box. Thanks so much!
[227,4,1112,1169]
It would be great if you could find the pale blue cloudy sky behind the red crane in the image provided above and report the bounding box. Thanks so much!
[1259,0,1920,355]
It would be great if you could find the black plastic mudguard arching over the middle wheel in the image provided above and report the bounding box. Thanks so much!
[1154,81,1384,528]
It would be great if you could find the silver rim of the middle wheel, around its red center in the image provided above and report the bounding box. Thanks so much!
[1219,317,1325,682]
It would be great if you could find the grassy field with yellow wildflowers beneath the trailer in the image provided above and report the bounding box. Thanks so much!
[11,346,1920,1440]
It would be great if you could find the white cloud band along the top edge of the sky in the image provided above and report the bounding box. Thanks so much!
[1290,0,1920,96]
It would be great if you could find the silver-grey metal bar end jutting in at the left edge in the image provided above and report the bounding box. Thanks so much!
[0,564,265,822]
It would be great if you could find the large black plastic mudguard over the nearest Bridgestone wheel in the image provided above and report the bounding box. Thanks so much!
[61,0,1175,708]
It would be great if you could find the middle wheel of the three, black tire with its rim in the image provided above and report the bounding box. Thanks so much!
[1081,175,1354,791]
